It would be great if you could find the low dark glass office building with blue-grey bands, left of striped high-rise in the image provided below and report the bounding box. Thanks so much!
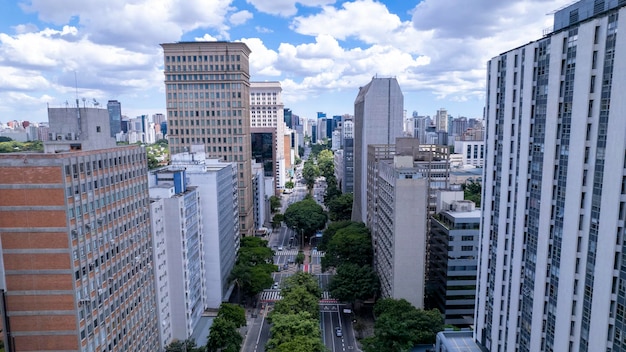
[425,199,480,327]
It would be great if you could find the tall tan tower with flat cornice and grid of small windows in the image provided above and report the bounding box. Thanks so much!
[161,42,254,236]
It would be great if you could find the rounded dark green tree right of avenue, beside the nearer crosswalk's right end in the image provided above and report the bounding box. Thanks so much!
[328,263,379,302]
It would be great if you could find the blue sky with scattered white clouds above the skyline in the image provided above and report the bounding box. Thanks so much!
[0,0,572,123]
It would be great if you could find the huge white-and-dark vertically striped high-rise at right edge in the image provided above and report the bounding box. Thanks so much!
[476,0,626,352]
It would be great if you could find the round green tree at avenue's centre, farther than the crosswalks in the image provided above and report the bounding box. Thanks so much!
[285,196,328,238]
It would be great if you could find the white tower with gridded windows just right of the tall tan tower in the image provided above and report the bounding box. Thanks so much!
[250,82,287,189]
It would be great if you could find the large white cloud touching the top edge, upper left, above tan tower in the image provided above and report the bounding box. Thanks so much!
[21,0,234,51]
